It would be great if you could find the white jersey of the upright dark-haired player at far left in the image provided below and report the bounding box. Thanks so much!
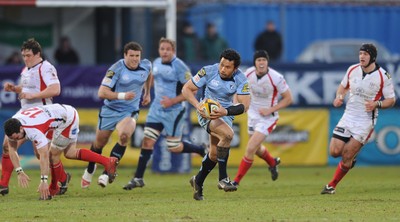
[20,60,60,109]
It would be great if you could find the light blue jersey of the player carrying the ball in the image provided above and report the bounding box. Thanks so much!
[192,63,250,108]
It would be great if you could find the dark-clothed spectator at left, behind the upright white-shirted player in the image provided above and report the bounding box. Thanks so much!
[54,36,79,65]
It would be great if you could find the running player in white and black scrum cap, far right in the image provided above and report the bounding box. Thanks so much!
[321,44,396,194]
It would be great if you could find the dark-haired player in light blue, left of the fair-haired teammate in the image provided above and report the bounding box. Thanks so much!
[81,42,152,188]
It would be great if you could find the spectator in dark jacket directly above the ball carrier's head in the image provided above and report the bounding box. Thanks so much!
[201,23,228,62]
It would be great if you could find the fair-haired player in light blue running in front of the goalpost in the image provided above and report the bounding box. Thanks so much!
[124,38,205,190]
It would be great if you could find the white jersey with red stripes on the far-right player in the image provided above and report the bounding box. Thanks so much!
[341,64,395,121]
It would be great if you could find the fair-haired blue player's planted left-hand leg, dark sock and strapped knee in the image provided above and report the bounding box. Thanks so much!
[123,122,160,190]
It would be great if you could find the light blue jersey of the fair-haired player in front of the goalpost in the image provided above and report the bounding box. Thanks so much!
[151,57,192,110]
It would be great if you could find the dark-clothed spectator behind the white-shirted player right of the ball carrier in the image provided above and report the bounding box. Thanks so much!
[254,21,283,61]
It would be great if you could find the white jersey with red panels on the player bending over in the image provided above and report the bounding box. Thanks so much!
[13,104,79,149]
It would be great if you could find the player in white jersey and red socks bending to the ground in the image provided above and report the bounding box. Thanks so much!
[4,104,118,200]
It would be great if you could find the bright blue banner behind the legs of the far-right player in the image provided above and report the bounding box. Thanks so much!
[326,108,400,166]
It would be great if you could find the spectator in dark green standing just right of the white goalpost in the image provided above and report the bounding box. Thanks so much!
[178,22,201,62]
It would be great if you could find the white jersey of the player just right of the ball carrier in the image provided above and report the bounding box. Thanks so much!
[245,66,289,117]
